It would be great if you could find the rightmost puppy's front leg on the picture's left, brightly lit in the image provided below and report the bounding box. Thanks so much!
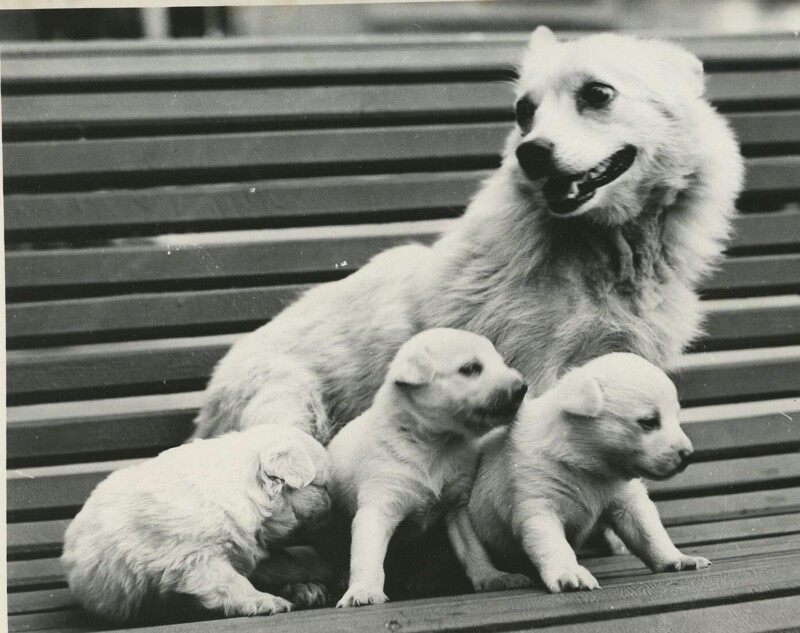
[516,500,600,593]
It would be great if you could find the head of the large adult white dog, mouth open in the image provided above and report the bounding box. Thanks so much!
[507,27,704,224]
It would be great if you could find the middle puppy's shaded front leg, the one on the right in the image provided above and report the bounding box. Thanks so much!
[446,506,531,591]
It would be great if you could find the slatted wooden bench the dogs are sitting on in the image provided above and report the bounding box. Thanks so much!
[1,34,800,632]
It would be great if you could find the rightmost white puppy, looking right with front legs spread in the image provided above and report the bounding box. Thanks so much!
[469,354,711,592]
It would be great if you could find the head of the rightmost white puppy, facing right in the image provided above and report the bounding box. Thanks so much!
[555,353,692,479]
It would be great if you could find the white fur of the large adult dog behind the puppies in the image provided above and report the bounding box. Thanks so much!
[191,27,742,450]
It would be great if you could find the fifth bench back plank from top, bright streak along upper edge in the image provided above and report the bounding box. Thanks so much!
[6,220,800,293]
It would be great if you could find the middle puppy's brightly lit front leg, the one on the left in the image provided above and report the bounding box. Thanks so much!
[336,504,403,608]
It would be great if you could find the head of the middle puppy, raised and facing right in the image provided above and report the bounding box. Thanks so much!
[387,328,527,435]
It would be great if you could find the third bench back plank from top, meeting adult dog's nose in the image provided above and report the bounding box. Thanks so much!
[5,121,800,184]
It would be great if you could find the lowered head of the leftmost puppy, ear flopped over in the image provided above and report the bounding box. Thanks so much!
[245,424,331,524]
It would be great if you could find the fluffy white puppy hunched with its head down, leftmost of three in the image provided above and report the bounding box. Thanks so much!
[61,425,330,623]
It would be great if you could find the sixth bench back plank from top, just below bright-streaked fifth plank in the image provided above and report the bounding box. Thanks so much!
[6,285,800,350]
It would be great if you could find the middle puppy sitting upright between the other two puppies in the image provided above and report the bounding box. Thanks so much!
[329,329,529,607]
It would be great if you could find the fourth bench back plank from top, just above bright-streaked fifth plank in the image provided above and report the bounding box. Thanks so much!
[4,157,800,232]
